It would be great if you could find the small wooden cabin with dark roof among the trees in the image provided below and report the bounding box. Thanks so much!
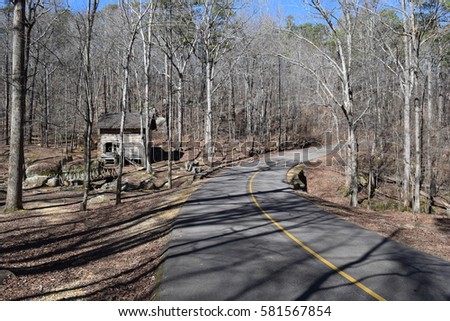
[97,113,165,164]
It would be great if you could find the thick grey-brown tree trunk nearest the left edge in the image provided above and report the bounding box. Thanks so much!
[5,0,26,212]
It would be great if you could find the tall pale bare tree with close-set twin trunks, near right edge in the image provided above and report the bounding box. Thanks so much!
[379,0,442,213]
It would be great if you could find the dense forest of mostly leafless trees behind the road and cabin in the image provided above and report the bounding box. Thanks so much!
[0,0,450,213]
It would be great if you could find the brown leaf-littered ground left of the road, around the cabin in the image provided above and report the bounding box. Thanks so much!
[0,147,246,300]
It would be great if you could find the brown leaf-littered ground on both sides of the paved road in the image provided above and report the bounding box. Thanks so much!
[0,149,450,300]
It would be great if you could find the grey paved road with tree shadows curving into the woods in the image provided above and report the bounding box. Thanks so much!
[157,150,450,301]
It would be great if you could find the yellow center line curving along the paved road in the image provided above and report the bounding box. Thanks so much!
[248,172,386,301]
